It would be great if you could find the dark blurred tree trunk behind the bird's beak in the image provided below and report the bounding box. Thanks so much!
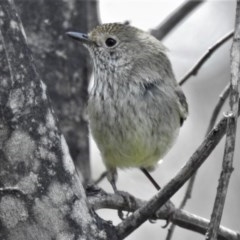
[16,0,98,183]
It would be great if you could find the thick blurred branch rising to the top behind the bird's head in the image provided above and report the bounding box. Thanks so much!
[151,0,205,40]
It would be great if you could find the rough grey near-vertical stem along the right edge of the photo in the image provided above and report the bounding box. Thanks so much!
[206,0,240,240]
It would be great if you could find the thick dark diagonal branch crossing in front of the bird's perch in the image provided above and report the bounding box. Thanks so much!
[116,116,227,239]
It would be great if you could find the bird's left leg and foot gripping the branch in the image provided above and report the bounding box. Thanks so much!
[107,168,136,220]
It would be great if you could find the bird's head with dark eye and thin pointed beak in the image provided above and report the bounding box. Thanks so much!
[67,23,164,67]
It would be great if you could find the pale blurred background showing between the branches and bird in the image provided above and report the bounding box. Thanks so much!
[90,0,240,240]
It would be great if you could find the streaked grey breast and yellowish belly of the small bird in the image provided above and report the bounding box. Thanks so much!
[88,79,179,168]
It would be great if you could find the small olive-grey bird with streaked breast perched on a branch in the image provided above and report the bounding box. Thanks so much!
[67,23,188,192]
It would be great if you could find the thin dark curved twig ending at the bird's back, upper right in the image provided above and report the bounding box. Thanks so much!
[179,31,233,85]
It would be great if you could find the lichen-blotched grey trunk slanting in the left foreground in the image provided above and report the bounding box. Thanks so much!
[0,0,116,240]
